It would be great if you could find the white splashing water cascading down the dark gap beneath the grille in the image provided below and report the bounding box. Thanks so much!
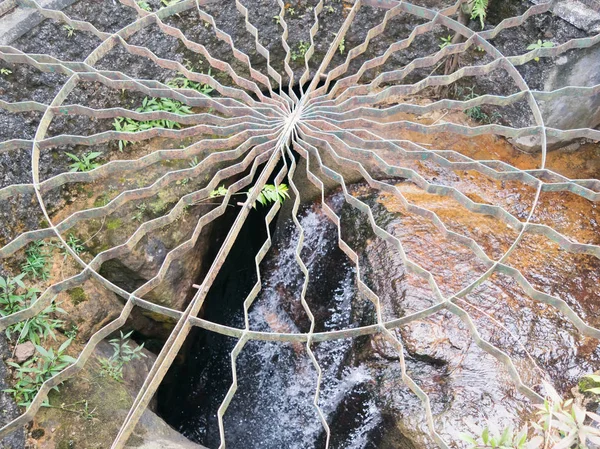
[225,204,381,449]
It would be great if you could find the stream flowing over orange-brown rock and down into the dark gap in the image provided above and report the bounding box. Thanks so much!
[158,131,600,449]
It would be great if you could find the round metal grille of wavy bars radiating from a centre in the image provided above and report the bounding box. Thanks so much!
[0,0,600,448]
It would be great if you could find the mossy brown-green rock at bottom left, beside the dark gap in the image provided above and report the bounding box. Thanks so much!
[33,342,202,449]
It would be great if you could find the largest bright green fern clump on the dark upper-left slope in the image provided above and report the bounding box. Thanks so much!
[113,96,192,151]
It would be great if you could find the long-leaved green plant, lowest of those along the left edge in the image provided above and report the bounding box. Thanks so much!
[4,339,76,407]
